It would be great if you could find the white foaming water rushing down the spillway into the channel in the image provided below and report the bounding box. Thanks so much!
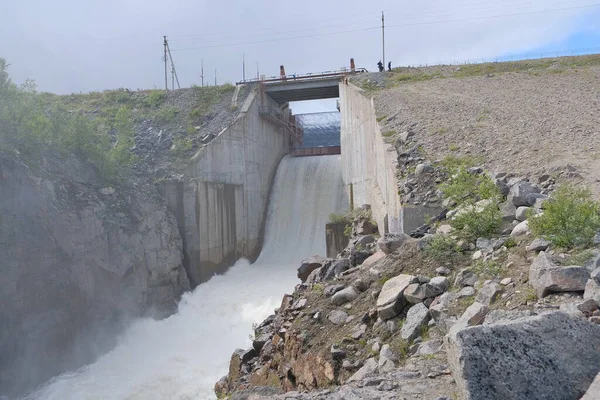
[27,156,346,400]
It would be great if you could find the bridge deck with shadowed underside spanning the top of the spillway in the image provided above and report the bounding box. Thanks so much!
[264,77,340,104]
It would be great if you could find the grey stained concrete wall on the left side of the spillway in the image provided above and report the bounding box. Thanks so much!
[163,92,290,287]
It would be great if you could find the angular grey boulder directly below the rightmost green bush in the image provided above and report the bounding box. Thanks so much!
[529,251,590,298]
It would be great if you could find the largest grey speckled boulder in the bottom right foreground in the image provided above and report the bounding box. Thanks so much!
[445,312,600,400]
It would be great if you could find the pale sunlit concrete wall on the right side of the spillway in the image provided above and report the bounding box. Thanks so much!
[339,82,404,233]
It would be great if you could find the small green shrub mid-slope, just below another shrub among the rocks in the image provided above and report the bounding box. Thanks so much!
[450,203,502,240]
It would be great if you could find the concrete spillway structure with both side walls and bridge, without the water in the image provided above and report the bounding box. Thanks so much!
[162,63,412,287]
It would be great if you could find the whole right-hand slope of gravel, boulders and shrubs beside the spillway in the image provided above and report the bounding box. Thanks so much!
[215,57,600,400]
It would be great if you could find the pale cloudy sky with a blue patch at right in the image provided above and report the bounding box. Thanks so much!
[0,0,600,111]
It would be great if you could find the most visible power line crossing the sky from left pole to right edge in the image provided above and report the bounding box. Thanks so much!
[168,4,600,51]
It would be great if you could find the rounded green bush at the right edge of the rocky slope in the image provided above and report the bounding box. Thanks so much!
[529,185,600,248]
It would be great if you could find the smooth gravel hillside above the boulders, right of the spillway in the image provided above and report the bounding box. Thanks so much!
[359,55,600,194]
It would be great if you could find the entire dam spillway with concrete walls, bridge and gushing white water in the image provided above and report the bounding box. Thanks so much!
[5,64,402,400]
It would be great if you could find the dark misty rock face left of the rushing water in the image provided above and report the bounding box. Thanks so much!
[0,153,189,394]
